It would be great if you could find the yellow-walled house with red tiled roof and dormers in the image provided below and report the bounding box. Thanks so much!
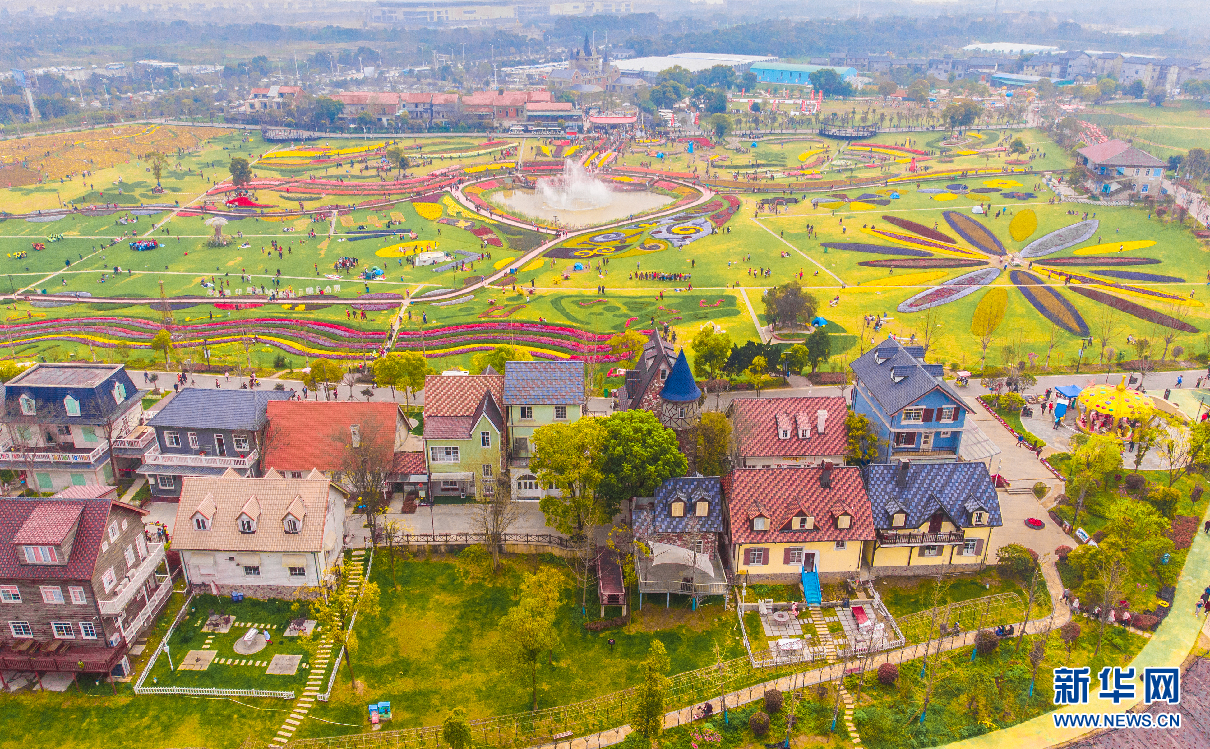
[722,463,875,582]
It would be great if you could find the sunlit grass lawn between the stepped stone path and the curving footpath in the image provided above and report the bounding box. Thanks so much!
[292,553,744,737]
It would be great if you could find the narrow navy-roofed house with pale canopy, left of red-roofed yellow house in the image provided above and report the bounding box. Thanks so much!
[632,476,730,600]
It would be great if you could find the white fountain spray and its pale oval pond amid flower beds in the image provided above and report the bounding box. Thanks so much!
[489,159,673,229]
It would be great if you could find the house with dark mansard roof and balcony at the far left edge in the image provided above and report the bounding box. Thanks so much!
[0,363,150,491]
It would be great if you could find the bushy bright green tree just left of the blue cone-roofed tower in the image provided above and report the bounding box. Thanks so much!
[592,410,688,519]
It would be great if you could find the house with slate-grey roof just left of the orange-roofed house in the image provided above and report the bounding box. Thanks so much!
[138,387,290,500]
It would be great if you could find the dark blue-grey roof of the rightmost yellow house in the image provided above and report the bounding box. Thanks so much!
[865,461,1003,530]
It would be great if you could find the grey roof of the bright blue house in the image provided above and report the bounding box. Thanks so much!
[849,336,966,414]
